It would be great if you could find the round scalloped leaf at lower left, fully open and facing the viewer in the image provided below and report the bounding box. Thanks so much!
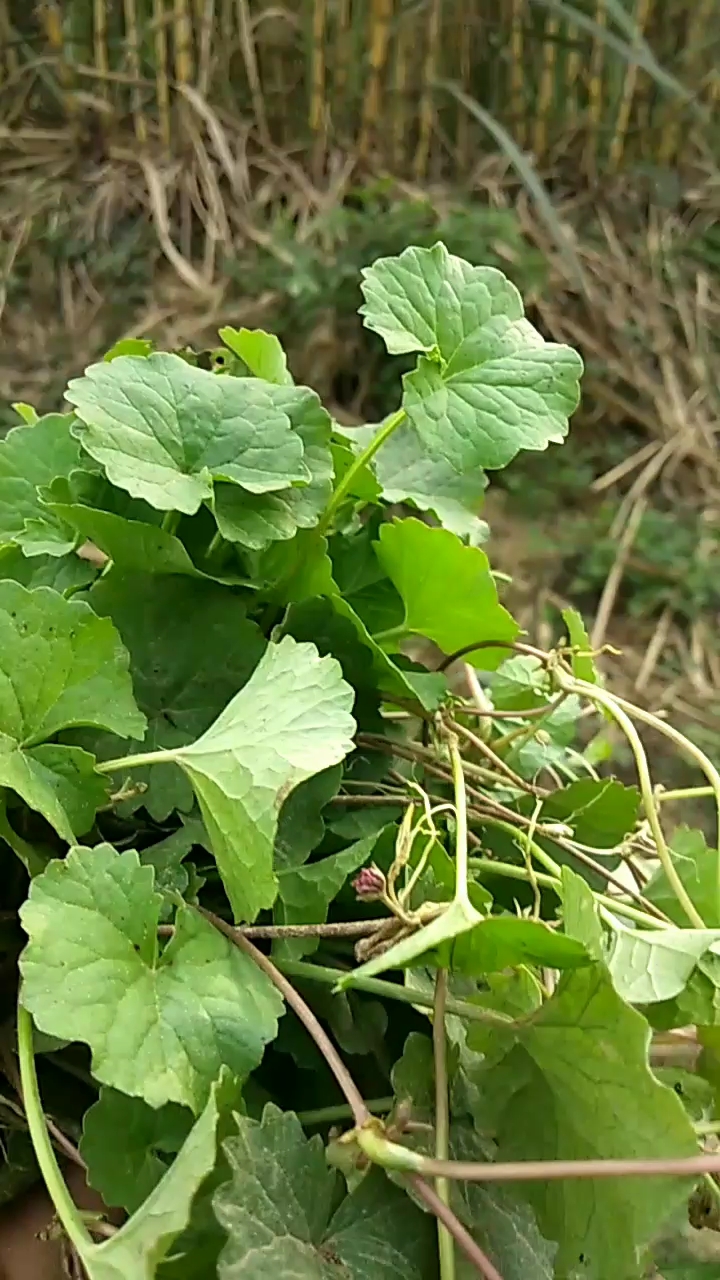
[20,845,283,1114]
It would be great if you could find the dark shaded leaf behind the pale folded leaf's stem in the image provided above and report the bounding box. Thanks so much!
[90,570,265,822]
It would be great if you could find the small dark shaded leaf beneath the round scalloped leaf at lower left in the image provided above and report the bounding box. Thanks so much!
[79,1088,192,1213]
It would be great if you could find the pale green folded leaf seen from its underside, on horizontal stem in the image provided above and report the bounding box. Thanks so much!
[173,636,355,920]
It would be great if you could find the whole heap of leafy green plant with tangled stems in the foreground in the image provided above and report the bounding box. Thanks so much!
[0,244,720,1280]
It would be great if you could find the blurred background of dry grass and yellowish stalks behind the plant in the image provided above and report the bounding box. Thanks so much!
[0,0,720,744]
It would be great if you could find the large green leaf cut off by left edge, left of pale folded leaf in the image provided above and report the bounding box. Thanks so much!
[0,581,145,842]
